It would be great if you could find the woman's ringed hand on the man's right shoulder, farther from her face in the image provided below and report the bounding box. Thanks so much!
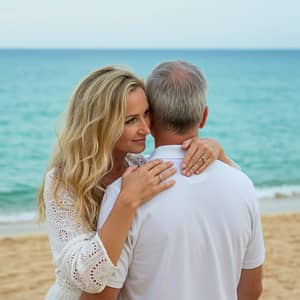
[181,137,223,176]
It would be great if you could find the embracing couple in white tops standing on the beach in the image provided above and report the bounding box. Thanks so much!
[38,61,264,300]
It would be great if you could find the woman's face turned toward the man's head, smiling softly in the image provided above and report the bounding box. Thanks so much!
[115,88,150,154]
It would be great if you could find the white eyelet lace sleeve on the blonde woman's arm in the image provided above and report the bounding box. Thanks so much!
[44,170,117,293]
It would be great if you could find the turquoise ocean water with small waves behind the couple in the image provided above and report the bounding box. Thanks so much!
[0,50,300,222]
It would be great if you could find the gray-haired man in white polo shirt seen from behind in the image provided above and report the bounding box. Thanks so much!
[85,61,264,300]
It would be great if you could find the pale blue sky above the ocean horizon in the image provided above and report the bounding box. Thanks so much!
[0,0,300,49]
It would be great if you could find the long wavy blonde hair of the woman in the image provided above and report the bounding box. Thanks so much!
[38,66,145,230]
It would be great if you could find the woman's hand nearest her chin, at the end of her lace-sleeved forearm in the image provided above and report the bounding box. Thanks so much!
[121,159,176,208]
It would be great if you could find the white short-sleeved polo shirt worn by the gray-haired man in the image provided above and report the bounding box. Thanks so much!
[98,146,264,300]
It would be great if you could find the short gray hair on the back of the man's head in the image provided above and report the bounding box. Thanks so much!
[146,61,207,134]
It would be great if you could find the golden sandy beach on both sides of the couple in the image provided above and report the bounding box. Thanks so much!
[0,214,300,300]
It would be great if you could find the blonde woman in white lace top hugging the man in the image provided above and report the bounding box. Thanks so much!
[38,67,234,300]
